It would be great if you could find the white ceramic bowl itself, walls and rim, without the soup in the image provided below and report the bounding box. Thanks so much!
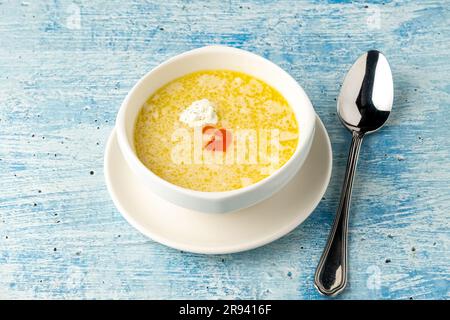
[116,46,315,213]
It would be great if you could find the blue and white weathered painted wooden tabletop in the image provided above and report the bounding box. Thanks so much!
[0,0,450,299]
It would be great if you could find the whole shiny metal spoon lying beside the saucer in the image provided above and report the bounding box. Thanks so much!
[314,50,394,296]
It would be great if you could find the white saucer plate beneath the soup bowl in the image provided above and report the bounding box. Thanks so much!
[104,117,332,254]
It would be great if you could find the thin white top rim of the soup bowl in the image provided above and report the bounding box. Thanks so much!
[116,45,316,199]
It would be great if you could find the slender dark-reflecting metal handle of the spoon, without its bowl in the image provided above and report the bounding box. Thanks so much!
[314,131,364,296]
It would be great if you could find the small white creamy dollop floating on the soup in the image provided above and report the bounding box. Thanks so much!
[180,99,218,128]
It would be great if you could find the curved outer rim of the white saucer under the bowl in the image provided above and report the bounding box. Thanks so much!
[103,115,333,254]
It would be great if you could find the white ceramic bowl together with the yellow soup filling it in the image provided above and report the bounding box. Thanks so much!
[116,46,315,212]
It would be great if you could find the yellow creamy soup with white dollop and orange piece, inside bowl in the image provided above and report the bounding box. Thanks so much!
[134,70,299,191]
